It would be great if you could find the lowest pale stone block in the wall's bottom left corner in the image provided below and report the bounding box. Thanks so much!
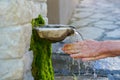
[0,59,24,80]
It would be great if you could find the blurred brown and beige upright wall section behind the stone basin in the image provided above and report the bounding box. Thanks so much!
[47,0,79,24]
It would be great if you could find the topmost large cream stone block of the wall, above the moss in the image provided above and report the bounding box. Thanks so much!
[0,0,47,27]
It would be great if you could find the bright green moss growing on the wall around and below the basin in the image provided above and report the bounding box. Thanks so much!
[30,15,54,80]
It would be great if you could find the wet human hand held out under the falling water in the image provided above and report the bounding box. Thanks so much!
[62,40,111,61]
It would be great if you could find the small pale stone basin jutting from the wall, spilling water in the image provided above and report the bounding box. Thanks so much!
[36,27,74,42]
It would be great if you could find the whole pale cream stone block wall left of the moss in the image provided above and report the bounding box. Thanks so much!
[0,0,48,80]
